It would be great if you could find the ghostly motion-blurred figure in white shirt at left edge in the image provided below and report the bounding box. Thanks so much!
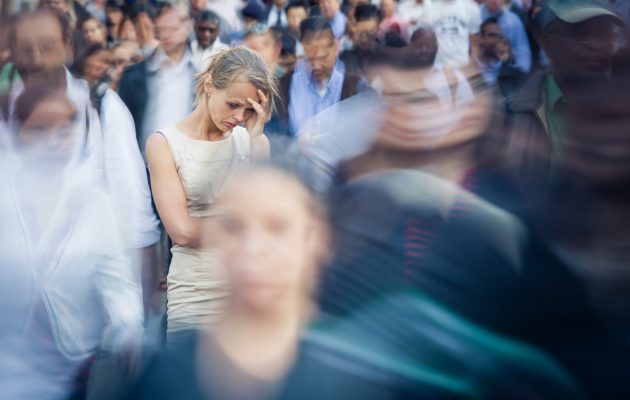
[0,83,143,399]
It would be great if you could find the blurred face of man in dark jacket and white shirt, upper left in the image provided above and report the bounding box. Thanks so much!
[155,3,192,54]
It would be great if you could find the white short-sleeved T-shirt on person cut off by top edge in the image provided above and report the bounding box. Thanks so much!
[420,0,481,68]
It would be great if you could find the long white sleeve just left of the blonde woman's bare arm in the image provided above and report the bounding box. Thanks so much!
[100,90,160,249]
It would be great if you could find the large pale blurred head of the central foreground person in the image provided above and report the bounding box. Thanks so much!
[216,166,327,317]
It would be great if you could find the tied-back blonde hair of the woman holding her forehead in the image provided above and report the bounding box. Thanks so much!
[195,46,279,112]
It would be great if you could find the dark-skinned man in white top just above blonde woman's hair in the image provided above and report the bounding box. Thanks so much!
[191,10,233,72]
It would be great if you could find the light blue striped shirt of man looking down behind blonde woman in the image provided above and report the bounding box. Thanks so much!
[289,60,345,136]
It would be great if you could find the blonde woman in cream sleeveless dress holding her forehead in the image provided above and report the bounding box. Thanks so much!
[146,47,277,344]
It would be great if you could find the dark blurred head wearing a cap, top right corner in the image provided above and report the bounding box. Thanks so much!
[532,0,622,80]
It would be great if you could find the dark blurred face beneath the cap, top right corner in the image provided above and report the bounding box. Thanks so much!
[541,17,617,78]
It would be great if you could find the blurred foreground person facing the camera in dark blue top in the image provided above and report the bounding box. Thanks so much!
[130,167,396,399]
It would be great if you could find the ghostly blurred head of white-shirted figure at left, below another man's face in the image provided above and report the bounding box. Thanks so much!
[15,84,77,164]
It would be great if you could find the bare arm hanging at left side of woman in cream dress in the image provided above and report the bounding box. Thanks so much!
[147,133,205,247]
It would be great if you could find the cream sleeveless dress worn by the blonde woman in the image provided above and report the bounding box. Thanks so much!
[159,125,251,335]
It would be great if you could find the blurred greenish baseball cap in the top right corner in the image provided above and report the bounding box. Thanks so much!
[538,0,622,26]
